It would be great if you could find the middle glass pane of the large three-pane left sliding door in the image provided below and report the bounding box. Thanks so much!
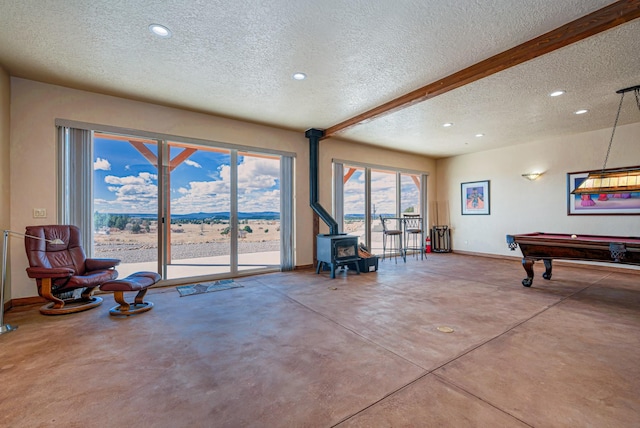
[166,142,232,279]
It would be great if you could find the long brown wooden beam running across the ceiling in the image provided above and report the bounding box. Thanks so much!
[322,0,640,139]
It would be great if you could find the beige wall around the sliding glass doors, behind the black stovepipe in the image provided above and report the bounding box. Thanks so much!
[7,78,435,298]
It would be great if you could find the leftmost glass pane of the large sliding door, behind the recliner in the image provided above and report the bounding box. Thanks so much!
[92,133,158,277]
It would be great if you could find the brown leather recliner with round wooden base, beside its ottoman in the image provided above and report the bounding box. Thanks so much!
[24,225,120,315]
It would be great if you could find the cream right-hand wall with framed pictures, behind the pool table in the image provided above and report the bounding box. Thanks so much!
[437,124,640,256]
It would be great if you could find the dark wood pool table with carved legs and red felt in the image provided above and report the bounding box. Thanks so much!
[507,232,640,287]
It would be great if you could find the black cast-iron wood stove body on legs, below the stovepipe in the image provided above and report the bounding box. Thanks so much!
[316,234,360,278]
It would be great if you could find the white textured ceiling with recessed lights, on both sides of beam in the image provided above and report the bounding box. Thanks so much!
[0,0,640,161]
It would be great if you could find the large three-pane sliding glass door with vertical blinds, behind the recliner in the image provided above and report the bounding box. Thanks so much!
[59,123,293,280]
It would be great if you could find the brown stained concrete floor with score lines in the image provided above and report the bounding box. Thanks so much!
[0,254,640,428]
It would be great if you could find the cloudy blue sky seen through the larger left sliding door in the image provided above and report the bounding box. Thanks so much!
[93,138,280,214]
